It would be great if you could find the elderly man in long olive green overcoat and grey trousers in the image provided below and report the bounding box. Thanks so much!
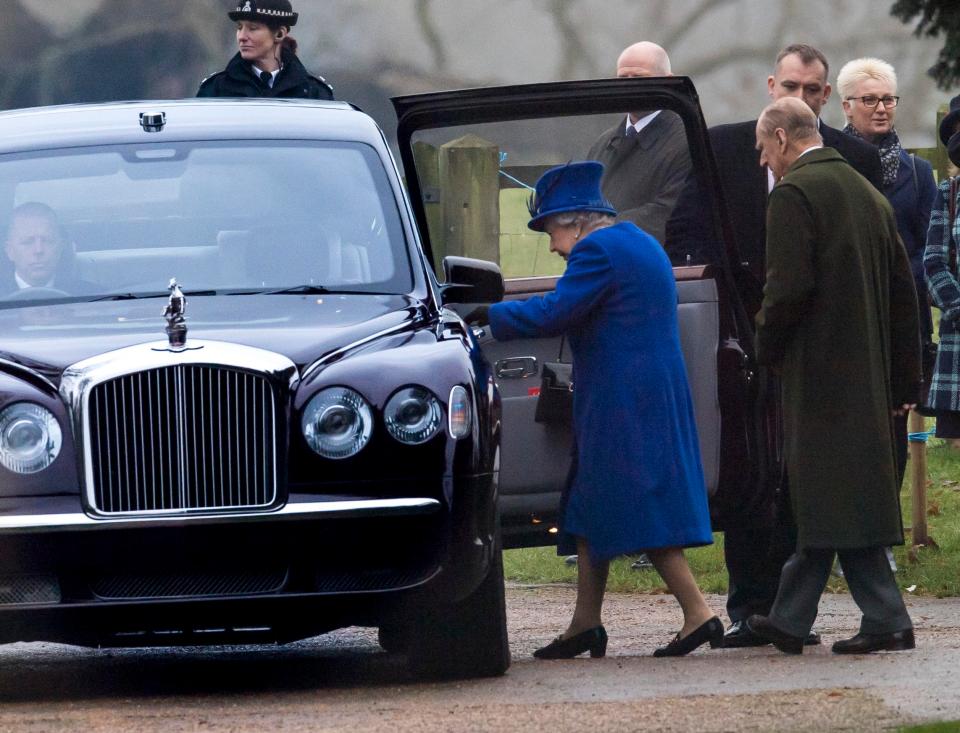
[747,98,920,654]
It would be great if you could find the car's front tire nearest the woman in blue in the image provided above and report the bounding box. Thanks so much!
[404,543,510,679]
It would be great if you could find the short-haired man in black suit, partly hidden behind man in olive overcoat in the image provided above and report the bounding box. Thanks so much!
[716,44,882,646]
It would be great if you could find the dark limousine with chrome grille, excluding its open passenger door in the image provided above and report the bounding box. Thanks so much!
[0,101,509,675]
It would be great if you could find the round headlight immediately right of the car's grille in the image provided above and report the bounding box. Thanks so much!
[301,387,373,459]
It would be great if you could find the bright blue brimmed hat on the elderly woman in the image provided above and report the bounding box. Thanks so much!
[527,160,617,232]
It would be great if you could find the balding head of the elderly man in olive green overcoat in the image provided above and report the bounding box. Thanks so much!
[757,97,823,180]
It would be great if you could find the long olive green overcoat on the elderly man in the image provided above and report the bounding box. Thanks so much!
[757,148,920,549]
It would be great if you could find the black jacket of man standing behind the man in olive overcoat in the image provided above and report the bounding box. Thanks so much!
[709,120,883,282]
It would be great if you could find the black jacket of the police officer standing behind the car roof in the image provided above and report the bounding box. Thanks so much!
[197,48,333,99]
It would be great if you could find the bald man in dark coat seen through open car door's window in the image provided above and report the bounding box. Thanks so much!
[587,41,690,243]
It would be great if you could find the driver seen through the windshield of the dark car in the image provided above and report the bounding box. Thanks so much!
[0,202,92,297]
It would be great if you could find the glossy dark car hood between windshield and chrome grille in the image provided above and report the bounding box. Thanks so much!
[0,294,429,381]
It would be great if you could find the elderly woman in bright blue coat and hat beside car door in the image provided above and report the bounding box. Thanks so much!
[489,161,723,659]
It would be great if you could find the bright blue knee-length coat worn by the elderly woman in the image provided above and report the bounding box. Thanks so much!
[490,223,713,559]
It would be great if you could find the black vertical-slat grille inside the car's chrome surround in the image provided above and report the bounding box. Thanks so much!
[87,365,277,515]
